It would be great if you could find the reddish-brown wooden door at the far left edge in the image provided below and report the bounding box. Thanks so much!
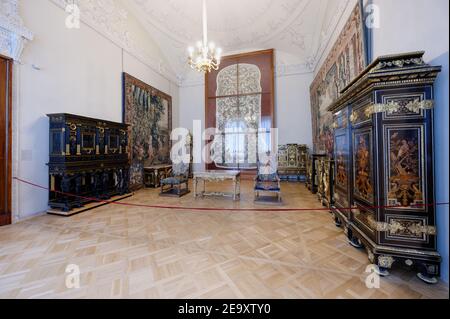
[0,56,12,226]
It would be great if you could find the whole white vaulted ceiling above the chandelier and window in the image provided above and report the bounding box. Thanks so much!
[126,0,352,83]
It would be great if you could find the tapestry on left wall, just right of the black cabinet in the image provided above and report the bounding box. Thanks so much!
[123,73,172,189]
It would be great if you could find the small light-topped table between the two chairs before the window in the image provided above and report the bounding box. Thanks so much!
[194,171,241,200]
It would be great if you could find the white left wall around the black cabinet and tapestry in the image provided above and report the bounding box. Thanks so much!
[13,0,179,221]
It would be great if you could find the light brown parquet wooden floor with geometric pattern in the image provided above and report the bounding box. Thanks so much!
[0,181,448,299]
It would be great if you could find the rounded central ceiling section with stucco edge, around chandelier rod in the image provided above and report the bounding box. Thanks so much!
[130,0,313,50]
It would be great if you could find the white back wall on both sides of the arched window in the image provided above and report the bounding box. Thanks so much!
[179,69,312,169]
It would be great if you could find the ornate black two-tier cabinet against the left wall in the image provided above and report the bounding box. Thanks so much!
[47,113,129,212]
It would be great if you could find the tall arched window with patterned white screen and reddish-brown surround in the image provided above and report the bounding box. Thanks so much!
[205,50,274,170]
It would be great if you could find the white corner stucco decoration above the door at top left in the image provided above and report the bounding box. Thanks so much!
[0,0,33,61]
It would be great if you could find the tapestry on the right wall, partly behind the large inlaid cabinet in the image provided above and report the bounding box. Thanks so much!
[310,1,367,155]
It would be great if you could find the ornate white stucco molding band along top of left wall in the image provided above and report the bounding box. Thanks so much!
[50,0,181,85]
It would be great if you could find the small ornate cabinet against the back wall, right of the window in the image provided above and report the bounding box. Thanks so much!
[278,144,308,181]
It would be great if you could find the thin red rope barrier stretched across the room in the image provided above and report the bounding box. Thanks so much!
[13,177,449,212]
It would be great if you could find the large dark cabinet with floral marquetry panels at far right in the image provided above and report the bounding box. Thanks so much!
[329,52,441,282]
